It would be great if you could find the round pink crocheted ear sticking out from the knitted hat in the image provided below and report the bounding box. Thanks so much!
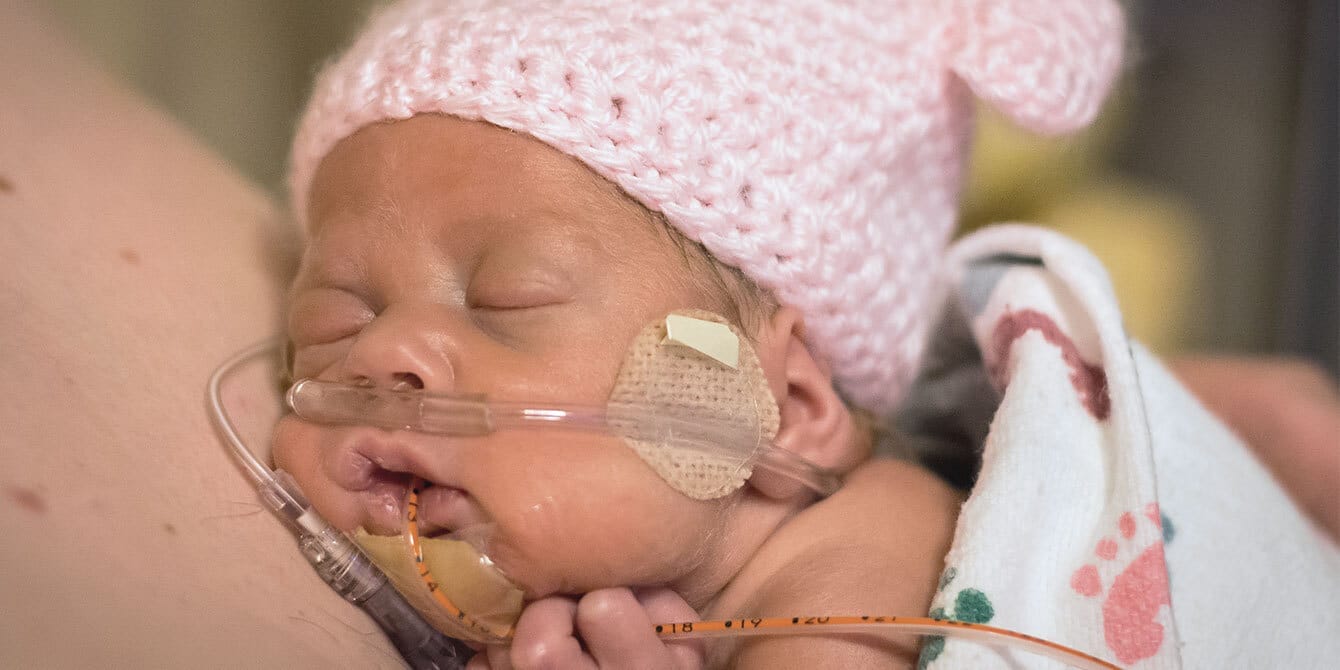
[950,0,1126,134]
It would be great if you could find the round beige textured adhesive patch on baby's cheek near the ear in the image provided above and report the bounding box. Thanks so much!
[610,310,780,500]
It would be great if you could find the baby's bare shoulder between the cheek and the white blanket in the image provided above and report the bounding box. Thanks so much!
[714,460,962,667]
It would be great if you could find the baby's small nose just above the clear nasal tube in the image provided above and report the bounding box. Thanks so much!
[343,308,456,393]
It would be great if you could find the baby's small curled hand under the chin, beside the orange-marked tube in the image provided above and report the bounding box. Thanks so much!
[466,588,704,670]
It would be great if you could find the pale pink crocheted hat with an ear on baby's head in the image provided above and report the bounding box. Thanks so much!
[289,0,1123,413]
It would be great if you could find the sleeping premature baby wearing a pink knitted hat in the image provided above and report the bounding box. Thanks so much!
[266,1,1120,667]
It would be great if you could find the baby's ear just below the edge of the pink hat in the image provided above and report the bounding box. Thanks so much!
[749,307,870,498]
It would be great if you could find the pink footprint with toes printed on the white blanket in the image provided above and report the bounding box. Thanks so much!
[1071,503,1170,663]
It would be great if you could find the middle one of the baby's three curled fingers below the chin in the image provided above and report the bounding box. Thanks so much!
[576,588,702,670]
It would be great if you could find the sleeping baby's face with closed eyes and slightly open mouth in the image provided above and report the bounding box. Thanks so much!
[273,115,730,596]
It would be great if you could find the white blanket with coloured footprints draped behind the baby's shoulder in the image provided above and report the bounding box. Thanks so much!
[900,225,1340,670]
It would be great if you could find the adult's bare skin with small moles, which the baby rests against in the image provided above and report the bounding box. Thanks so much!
[0,1,399,667]
